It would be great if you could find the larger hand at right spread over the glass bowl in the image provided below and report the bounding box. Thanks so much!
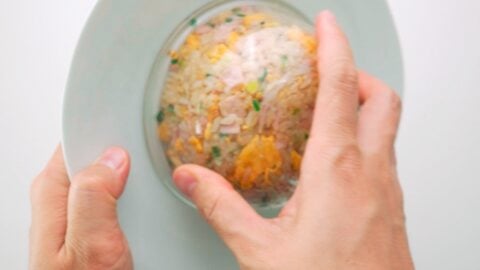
[174,12,414,270]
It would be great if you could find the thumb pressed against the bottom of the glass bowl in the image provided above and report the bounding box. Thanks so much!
[173,165,266,251]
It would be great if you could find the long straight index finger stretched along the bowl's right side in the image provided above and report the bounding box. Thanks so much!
[310,11,358,148]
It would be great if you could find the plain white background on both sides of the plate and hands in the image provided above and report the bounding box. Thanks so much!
[0,0,480,270]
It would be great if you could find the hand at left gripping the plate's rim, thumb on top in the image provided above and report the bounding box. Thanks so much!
[30,147,133,270]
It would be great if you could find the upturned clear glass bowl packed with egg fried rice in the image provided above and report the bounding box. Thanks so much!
[157,0,318,207]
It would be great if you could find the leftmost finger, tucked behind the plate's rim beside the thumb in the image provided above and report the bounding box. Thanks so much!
[30,146,70,253]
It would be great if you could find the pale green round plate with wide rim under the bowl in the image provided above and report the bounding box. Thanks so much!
[63,0,403,270]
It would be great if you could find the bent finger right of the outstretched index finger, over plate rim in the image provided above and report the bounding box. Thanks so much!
[358,71,401,155]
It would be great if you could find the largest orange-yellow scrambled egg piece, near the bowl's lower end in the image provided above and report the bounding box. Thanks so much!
[233,135,282,190]
